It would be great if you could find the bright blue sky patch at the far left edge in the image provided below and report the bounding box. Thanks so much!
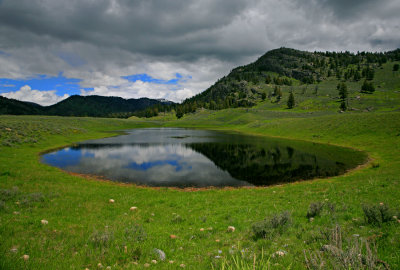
[0,72,82,96]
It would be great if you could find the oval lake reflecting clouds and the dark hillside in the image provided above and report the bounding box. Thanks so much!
[42,128,367,188]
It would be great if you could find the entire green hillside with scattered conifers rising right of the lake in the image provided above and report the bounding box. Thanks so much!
[178,48,400,116]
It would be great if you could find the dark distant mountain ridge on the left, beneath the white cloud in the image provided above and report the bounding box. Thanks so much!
[0,95,174,118]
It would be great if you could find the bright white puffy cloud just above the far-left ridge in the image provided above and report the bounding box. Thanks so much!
[1,85,69,106]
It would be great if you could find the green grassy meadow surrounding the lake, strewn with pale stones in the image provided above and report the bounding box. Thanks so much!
[0,109,400,269]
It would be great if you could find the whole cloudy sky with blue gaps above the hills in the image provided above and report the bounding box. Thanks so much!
[0,0,400,105]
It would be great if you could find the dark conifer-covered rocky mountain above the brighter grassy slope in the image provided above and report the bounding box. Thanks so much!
[181,48,400,115]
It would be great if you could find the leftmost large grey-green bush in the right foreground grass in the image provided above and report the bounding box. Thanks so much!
[252,211,291,239]
